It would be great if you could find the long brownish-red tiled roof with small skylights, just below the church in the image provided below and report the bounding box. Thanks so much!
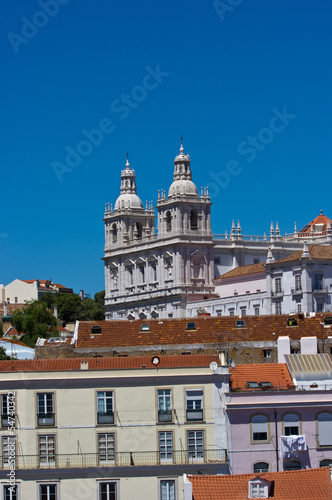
[75,313,332,350]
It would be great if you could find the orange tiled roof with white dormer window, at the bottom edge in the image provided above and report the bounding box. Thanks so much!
[188,467,332,500]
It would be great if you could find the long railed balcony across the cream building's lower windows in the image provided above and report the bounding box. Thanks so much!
[0,449,227,471]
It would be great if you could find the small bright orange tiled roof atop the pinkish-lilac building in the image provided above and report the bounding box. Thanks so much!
[230,363,294,391]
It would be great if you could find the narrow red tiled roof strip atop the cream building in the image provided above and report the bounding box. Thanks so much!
[0,354,220,373]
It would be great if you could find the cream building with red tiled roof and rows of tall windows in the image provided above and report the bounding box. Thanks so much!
[0,355,229,500]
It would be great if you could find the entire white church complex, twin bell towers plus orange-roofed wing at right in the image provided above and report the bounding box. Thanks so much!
[103,143,332,320]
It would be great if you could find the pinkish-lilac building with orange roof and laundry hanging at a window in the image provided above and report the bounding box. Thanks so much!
[226,364,332,474]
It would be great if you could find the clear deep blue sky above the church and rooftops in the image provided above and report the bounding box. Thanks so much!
[0,0,332,295]
